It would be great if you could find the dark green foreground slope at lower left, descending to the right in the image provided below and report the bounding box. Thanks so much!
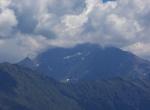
[0,63,81,110]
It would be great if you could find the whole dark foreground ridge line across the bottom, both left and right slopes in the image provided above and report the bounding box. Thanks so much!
[0,63,150,110]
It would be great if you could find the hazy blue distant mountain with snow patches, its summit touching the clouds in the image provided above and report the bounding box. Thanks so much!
[20,44,150,81]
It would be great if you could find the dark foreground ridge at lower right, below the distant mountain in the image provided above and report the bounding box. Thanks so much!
[60,78,150,110]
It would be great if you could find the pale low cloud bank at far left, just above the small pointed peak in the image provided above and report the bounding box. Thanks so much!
[0,33,50,62]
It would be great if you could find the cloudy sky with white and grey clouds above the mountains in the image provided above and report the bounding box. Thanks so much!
[0,0,150,62]
